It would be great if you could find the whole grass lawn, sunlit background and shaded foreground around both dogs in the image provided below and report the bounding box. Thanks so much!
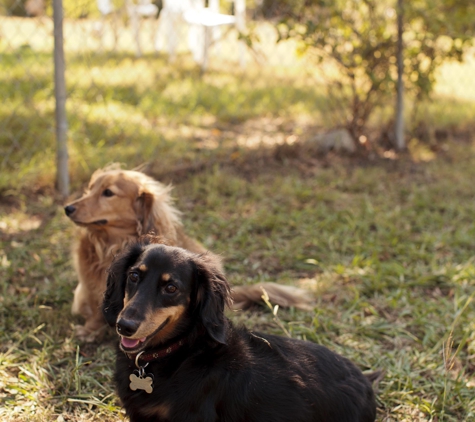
[0,14,475,422]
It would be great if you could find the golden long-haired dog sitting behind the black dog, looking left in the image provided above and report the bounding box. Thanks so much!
[64,165,310,341]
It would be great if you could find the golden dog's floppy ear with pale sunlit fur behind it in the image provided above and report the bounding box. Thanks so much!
[136,174,181,244]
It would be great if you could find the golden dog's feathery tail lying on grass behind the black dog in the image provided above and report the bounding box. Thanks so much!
[231,283,313,310]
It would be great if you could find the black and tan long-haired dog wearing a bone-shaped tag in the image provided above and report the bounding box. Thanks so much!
[103,237,376,422]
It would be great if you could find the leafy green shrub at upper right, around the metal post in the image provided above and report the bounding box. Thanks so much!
[277,0,475,144]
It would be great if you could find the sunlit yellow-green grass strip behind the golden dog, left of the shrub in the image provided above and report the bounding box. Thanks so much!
[0,48,330,193]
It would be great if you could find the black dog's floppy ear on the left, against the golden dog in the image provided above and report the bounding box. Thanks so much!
[102,243,143,327]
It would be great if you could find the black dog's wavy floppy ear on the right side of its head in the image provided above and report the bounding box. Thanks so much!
[194,254,231,344]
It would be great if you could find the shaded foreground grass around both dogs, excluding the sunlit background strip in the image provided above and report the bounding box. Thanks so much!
[0,143,475,421]
